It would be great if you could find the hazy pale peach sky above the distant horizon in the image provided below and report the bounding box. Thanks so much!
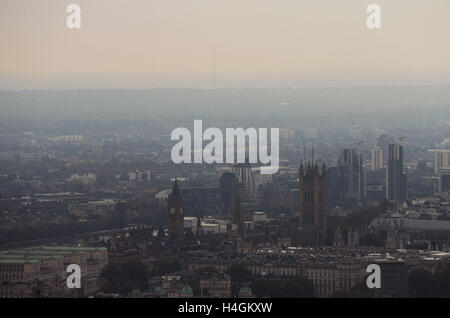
[0,0,450,89]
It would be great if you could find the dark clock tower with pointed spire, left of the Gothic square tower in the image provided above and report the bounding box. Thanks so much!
[167,180,184,238]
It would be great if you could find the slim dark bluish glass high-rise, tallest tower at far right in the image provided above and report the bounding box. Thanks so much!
[386,144,406,203]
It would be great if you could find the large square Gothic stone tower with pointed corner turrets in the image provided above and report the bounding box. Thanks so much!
[298,161,327,246]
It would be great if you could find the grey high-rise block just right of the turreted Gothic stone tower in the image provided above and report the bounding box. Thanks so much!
[338,148,366,202]
